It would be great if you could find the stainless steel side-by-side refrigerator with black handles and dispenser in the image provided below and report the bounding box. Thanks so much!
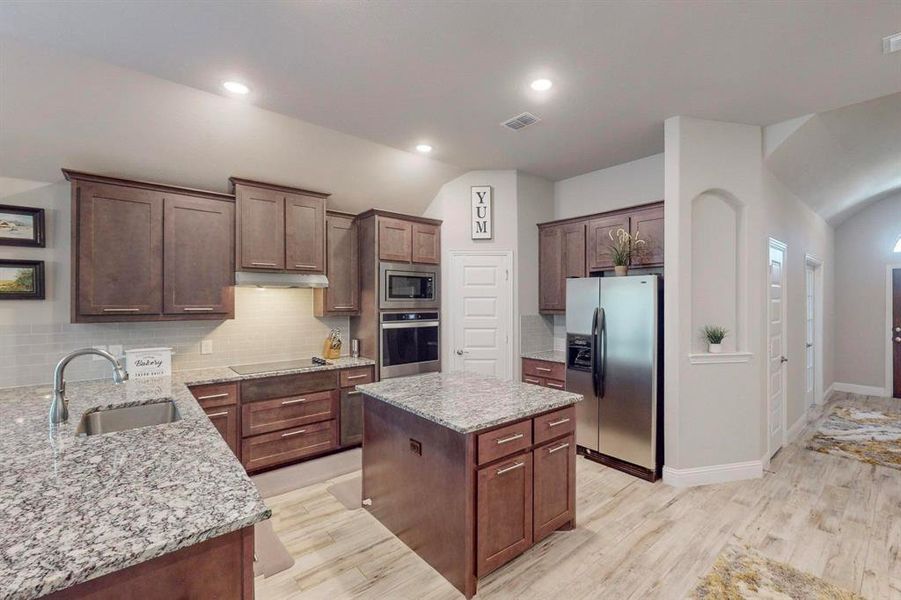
[566,275,662,481]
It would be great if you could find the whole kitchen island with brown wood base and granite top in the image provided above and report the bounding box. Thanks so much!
[357,373,582,598]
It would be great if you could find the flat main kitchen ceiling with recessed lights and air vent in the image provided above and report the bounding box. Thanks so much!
[0,0,901,180]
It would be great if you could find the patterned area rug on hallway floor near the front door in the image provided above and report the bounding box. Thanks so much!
[807,406,901,470]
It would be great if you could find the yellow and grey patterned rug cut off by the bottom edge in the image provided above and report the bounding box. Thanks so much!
[691,545,863,600]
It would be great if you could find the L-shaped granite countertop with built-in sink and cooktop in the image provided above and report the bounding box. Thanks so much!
[0,358,374,599]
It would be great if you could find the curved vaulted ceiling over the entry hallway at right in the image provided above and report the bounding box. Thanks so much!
[766,93,901,225]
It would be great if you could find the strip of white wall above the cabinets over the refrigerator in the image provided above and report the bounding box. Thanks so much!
[554,154,664,219]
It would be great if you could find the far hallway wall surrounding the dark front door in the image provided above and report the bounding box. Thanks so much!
[835,193,901,395]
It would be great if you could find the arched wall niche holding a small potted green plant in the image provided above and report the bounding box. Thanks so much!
[690,189,747,354]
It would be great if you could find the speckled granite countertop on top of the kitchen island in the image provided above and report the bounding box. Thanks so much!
[357,372,582,433]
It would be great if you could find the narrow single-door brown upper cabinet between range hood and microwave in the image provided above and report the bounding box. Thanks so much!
[313,212,360,317]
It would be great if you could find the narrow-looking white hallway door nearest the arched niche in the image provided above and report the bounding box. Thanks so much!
[767,239,788,457]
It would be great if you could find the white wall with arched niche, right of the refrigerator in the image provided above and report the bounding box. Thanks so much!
[664,117,834,481]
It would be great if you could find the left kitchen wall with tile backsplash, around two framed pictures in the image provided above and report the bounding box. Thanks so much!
[0,178,350,387]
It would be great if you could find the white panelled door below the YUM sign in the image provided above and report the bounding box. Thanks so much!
[448,252,513,379]
